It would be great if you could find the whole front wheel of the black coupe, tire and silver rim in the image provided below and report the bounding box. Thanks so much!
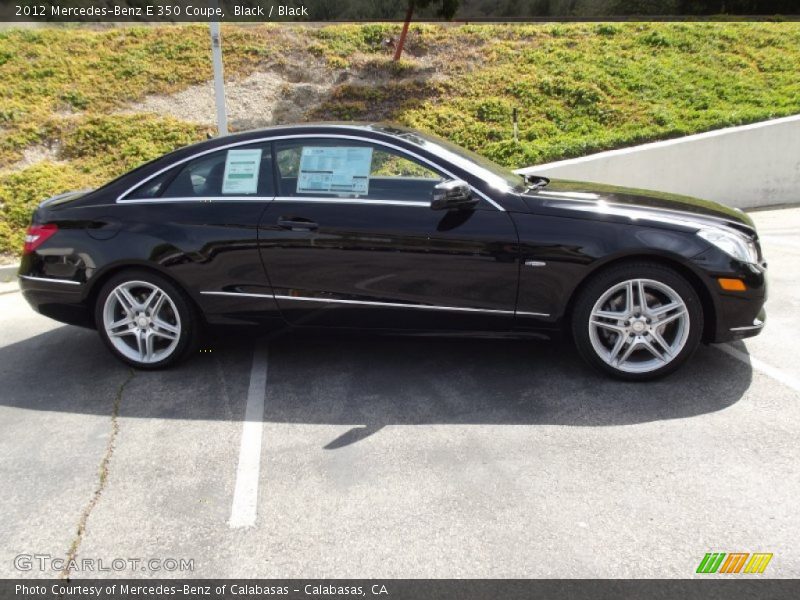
[572,263,703,381]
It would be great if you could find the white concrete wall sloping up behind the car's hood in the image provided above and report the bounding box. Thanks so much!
[518,115,800,208]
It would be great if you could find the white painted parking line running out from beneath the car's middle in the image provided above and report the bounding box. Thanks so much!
[228,343,267,528]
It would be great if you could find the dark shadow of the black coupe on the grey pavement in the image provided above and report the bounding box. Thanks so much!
[0,327,752,449]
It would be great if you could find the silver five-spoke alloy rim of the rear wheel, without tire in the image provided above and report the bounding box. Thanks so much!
[103,281,181,364]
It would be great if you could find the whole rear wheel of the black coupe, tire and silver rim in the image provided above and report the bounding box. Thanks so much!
[95,271,197,369]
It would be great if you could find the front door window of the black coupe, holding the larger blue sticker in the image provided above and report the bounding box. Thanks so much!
[276,139,445,202]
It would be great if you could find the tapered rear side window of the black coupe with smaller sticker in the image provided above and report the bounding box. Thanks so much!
[127,144,275,199]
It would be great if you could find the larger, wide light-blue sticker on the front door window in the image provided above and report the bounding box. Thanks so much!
[297,146,372,194]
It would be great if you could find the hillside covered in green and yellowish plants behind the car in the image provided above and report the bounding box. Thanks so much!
[0,23,800,254]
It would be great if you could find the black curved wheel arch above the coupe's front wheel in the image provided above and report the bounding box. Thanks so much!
[563,252,717,342]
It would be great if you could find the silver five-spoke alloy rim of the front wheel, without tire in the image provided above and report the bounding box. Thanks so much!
[589,279,690,373]
